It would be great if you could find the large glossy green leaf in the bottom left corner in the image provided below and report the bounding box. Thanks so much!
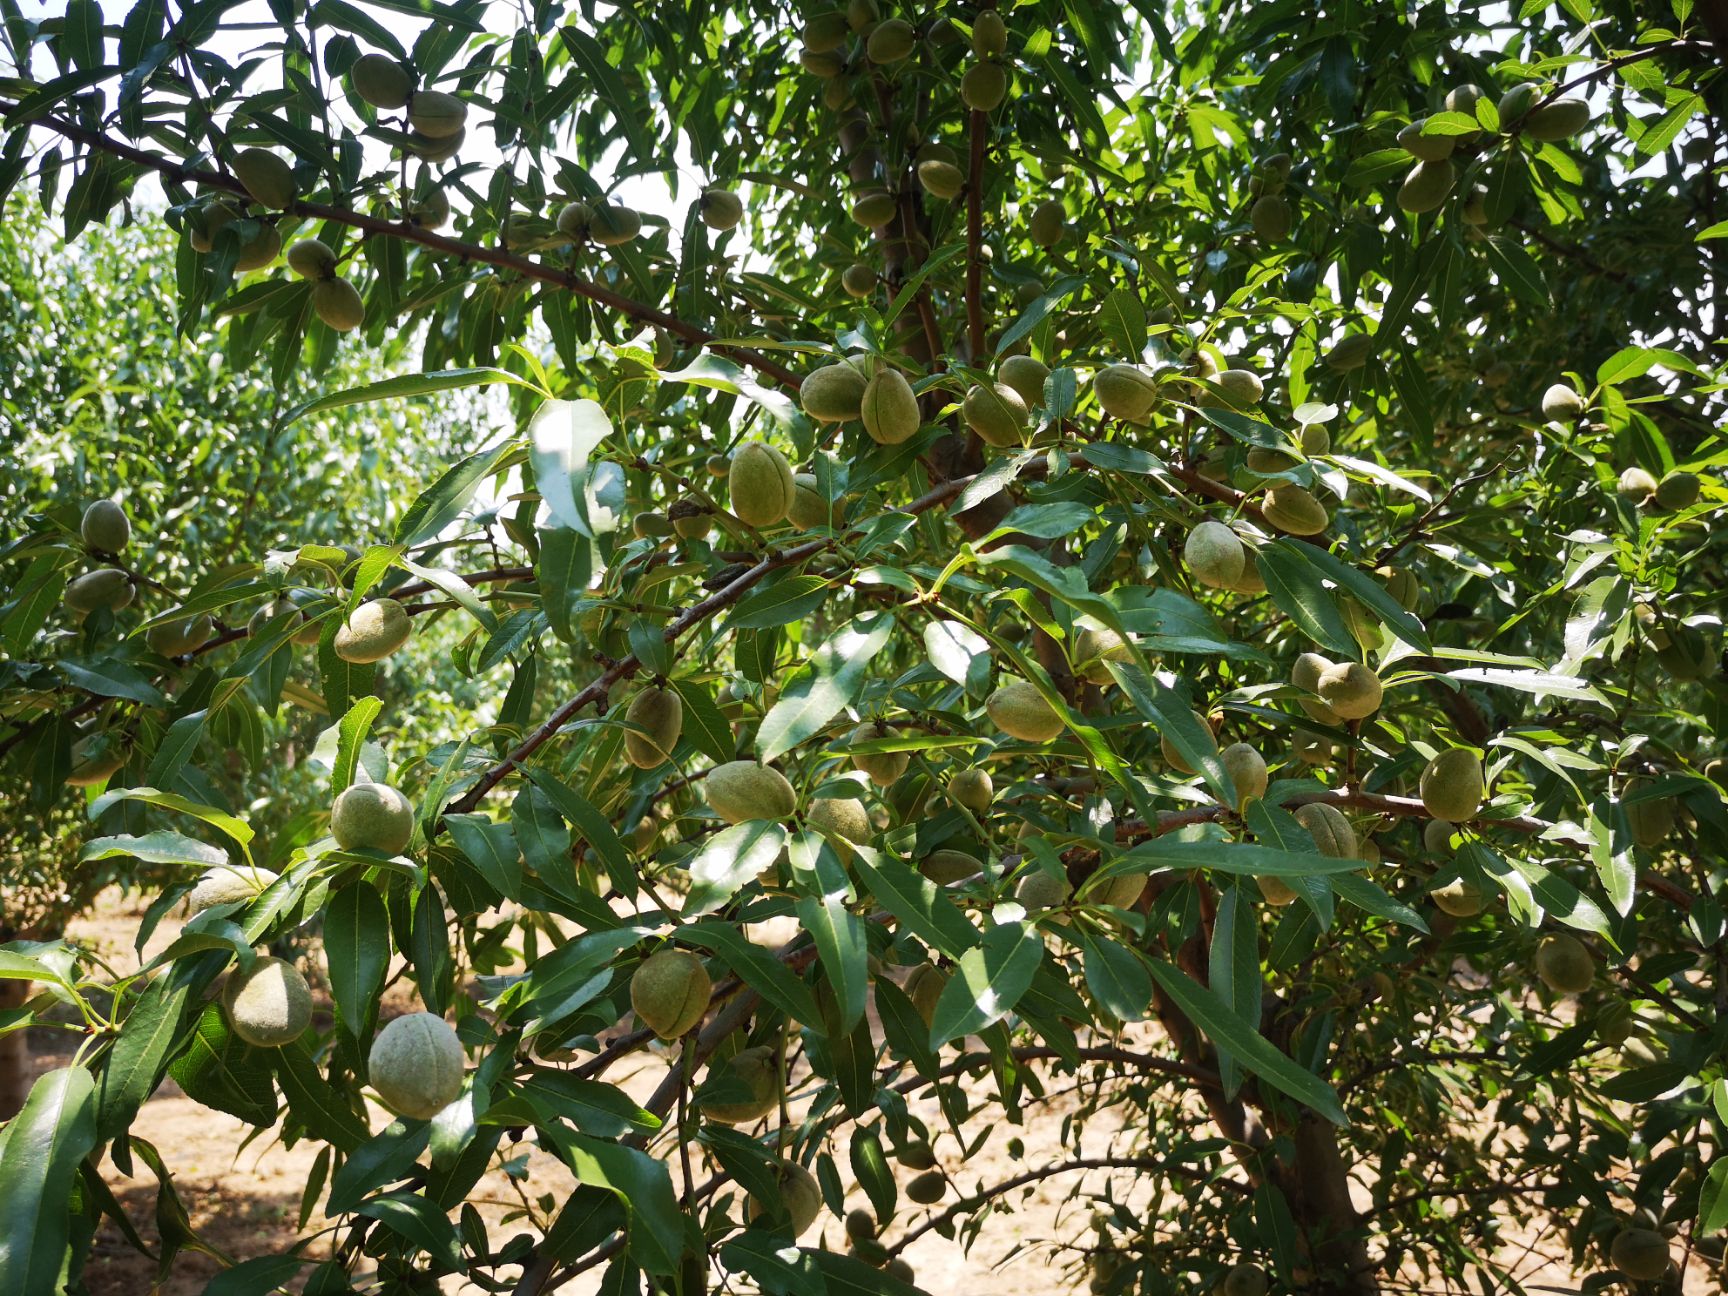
[0,1066,97,1296]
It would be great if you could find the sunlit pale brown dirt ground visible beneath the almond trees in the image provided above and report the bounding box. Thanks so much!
[10,893,1712,1296]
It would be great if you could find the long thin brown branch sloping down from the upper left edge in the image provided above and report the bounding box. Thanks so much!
[0,98,798,391]
